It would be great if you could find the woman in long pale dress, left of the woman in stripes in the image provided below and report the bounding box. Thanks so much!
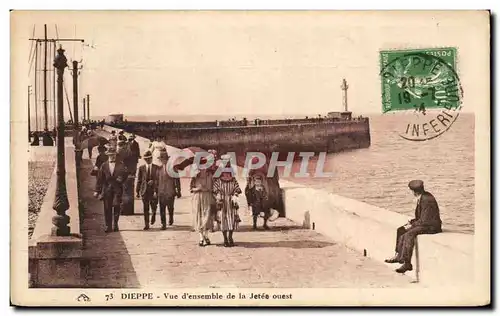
[190,158,213,247]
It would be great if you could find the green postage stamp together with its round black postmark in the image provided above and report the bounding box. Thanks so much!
[380,48,463,141]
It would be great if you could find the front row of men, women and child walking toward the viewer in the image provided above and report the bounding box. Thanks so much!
[94,132,279,247]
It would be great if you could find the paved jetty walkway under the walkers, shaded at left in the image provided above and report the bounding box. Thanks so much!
[81,143,412,288]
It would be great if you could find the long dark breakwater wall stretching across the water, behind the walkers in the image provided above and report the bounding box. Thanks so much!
[109,118,370,153]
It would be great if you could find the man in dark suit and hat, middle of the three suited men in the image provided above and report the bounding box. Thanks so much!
[136,150,160,230]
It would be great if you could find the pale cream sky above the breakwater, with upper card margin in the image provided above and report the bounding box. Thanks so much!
[11,11,489,121]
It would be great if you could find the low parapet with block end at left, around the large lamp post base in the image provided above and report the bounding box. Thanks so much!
[28,139,83,287]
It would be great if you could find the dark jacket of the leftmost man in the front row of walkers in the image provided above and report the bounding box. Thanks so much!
[95,161,128,206]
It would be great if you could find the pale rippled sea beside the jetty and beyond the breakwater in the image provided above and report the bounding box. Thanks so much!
[115,113,475,234]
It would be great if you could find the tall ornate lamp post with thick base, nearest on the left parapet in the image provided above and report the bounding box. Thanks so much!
[52,46,70,236]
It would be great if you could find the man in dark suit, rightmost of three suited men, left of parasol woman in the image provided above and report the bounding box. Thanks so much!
[153,150,180,230]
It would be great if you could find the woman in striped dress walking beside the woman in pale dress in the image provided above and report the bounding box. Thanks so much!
[213,156,241,247]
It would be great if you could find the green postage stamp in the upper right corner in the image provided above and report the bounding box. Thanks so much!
[380,47,461,114]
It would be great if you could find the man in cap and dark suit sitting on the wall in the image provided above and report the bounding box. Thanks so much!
[385,180,442,273]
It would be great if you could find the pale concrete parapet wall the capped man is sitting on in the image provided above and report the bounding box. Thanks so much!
[282,182,474,286]
